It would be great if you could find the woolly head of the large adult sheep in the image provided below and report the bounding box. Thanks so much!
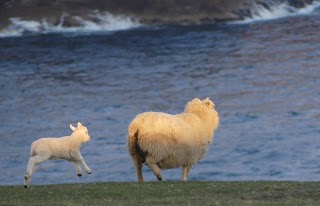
[185,97,219,130]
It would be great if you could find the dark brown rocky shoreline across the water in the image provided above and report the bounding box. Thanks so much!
[0,0,313,29]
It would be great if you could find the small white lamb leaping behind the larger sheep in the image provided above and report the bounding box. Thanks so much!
[24,122,92,188]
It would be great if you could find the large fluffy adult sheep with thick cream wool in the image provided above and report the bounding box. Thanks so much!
[127,97,219,182]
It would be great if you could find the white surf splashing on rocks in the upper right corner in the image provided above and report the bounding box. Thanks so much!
[235,1,320,23]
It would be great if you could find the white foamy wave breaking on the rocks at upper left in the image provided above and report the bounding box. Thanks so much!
[0,12,141,37]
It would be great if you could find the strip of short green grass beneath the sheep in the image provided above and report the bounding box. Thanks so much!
[0,181,320,206]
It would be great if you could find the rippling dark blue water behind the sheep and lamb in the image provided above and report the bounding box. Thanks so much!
[0,13,320,185]
